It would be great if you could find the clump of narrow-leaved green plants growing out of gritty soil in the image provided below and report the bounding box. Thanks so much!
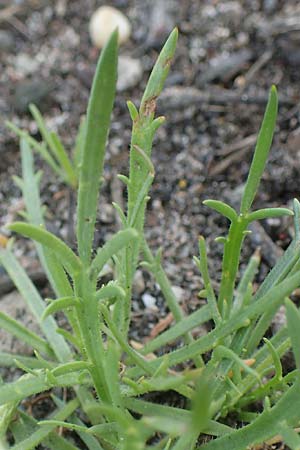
[0,30,300,450]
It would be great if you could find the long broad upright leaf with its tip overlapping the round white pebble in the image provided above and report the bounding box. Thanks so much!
[77,32,118,266]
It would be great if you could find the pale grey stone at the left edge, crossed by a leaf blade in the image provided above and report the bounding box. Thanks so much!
[0,291,41,356]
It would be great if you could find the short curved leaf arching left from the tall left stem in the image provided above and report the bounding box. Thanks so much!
[7,222,81,277]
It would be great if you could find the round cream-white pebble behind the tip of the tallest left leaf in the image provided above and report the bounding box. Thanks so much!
[89,6,131,48]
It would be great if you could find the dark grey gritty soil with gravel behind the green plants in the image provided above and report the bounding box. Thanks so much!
[0,0,300,448]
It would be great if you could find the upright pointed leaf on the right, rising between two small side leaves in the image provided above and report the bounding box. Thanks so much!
[241,86,278,214]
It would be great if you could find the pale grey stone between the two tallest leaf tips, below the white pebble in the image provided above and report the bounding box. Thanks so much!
[117,56,143,91]
